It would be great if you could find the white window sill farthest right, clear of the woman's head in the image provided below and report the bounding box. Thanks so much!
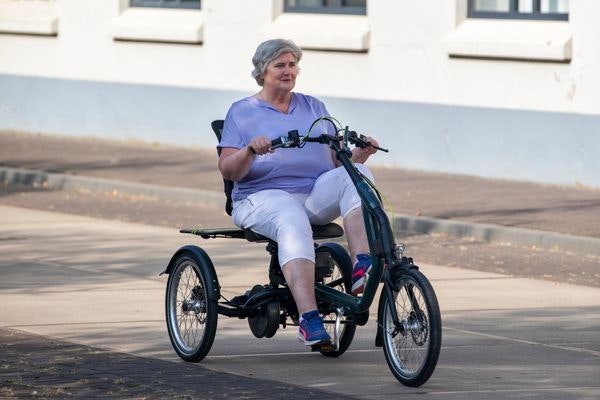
[442,19,573,62]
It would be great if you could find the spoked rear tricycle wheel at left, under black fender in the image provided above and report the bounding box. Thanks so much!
[165,252,218,362]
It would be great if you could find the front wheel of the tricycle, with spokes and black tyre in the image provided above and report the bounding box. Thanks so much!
[380,269,442,387]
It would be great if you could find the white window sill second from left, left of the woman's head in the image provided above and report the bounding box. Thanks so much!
[111,7,204,44]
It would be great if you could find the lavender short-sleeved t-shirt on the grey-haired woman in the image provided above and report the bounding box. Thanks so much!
[219,93,335,201]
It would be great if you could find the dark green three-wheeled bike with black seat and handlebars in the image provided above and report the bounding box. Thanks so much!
[164,117,442,387]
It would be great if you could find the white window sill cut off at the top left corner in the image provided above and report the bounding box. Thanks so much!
[0,2,58,36]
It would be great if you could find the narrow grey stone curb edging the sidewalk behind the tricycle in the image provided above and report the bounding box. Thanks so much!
[0,167,600,257]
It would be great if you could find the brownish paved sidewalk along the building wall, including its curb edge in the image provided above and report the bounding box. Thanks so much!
[0,132,600,256]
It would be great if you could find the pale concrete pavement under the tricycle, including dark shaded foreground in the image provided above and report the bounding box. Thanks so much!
[0,206,600,400]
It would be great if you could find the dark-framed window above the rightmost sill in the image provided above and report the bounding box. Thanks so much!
[467,0,569,21]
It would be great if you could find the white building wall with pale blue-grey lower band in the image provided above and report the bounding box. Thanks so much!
[0,0,600,186]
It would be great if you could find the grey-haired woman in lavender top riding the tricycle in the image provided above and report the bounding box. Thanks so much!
[219,39,377,345]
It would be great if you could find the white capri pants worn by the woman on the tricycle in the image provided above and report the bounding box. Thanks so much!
[231,164,373,266]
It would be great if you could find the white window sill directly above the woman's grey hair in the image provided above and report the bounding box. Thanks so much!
[264,13,371,52]
